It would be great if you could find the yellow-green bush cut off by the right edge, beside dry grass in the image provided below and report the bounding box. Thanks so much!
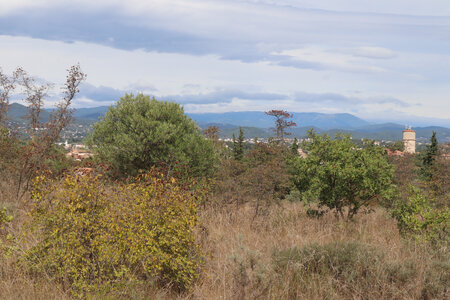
[392,187,450,244]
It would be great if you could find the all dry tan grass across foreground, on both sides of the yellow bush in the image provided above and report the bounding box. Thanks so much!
[0,179,450,299]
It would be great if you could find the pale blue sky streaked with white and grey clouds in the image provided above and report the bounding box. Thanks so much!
[0,0,450,126]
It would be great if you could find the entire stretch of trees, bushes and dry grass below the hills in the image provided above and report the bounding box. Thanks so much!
[0,67,450,299]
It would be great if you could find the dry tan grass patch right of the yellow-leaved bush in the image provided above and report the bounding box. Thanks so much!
[189,203,450,299]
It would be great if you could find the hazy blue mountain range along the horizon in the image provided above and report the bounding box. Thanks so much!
[8,103,450,143]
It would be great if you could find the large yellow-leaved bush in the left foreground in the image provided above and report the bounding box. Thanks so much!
[26,173,202,296]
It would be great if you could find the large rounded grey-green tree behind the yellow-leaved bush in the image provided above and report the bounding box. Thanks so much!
[88,94,216,177]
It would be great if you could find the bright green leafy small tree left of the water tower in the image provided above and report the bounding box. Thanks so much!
[292,131,393,220]
